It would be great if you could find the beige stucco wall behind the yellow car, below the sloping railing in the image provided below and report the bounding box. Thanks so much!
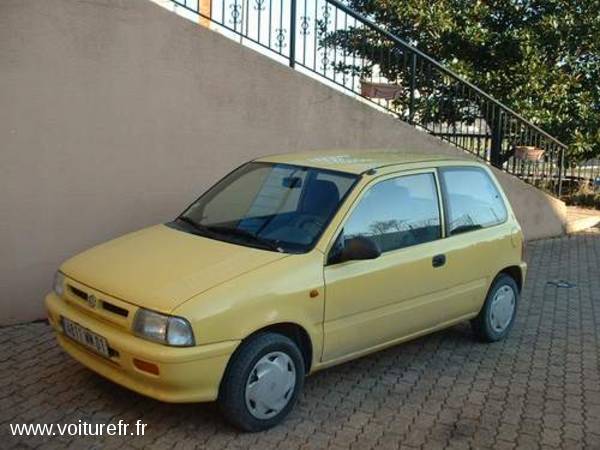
[0,0,563,324]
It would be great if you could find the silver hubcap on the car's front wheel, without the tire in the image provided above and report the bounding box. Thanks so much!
[246,352,296,419]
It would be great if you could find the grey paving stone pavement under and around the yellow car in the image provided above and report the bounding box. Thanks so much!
[0,229,600,450]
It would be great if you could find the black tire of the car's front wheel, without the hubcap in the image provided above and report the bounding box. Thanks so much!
[217,333,305,432]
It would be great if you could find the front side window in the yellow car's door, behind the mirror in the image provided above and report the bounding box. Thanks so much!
[342,173,441,253]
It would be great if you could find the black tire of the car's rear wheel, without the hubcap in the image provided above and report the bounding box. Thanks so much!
[471,273,519,342]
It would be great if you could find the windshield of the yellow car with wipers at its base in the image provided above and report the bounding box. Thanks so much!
[174,162,358,253]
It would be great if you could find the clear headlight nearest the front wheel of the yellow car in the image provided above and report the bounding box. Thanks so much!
[133,308,194,347]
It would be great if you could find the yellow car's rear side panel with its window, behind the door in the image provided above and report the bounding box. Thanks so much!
[438,166,520,324]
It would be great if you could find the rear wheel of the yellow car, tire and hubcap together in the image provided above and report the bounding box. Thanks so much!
[471,274,519,342]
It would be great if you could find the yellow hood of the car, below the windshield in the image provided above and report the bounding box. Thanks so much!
[61,225,287,313]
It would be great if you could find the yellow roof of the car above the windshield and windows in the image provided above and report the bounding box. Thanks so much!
[255,150,473,174]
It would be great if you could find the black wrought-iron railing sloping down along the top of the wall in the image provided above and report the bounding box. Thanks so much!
[171,0,574,196]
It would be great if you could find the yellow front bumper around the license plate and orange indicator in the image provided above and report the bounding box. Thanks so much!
[46,293,239,403]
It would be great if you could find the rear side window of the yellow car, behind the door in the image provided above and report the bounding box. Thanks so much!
[440,167,507,236]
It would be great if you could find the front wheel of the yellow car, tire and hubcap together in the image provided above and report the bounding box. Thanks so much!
[218,333,304,431]
